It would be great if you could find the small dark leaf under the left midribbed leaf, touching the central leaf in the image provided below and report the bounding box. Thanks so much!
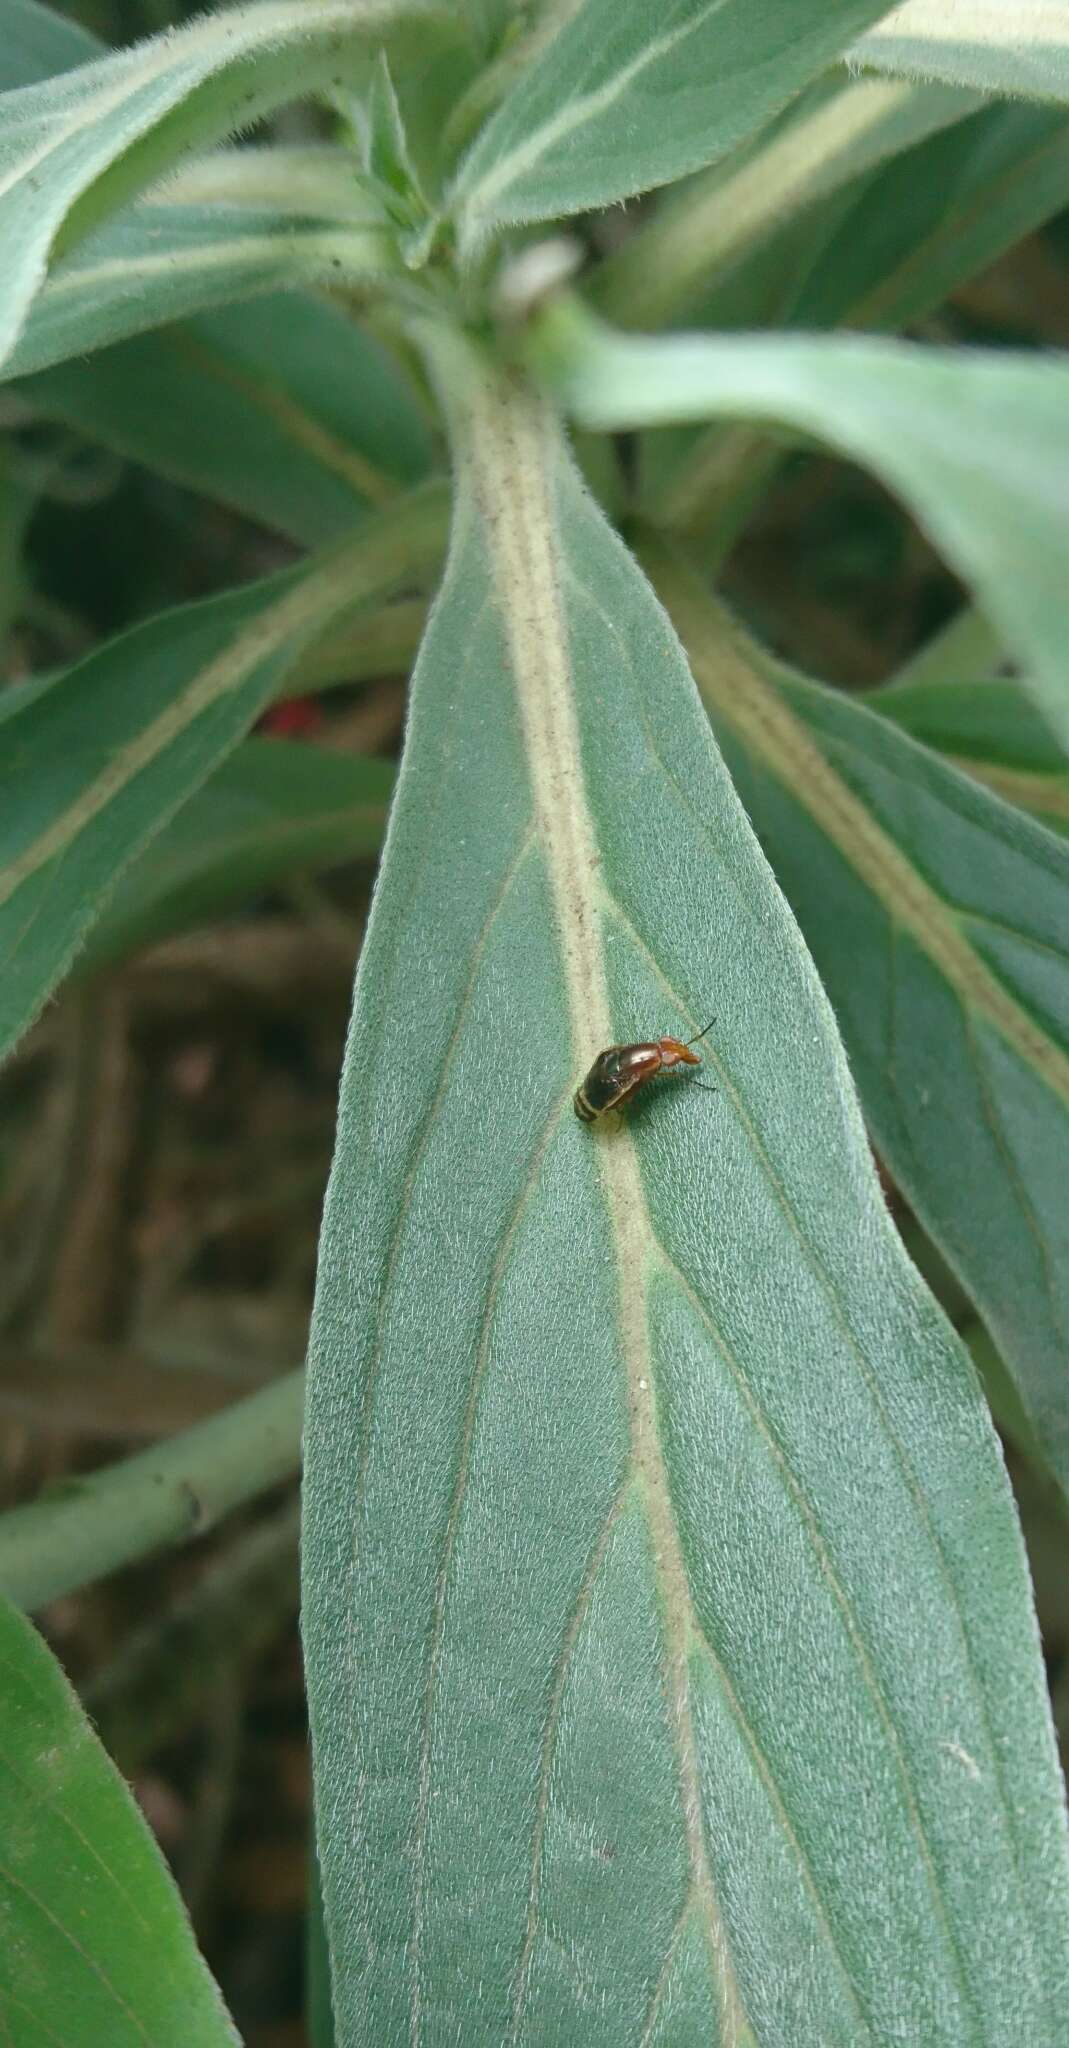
[80,739,393,969]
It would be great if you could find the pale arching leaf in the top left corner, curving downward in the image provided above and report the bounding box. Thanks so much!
[0,0,434,372]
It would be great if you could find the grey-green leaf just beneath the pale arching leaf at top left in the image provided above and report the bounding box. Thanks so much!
[0,207,399,379]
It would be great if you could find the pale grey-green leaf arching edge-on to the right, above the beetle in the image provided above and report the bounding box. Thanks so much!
[532,303,1069,741]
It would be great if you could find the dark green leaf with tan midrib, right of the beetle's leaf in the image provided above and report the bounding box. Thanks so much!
[653,553,1069,1495]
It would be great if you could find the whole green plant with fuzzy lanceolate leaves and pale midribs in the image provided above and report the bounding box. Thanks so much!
[0,0,1069,2048]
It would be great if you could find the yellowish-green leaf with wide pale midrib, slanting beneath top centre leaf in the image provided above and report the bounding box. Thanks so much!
[592,76,979,328]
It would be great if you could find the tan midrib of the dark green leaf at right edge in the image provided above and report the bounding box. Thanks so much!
[655,555,1069,1104]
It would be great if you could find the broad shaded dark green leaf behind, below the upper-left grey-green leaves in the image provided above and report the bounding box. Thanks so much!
[16,293,430,545]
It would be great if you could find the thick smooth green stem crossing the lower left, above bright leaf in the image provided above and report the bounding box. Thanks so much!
[0,1370,305,1612]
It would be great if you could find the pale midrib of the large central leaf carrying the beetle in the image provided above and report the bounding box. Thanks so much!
[461,373,752,2048]
